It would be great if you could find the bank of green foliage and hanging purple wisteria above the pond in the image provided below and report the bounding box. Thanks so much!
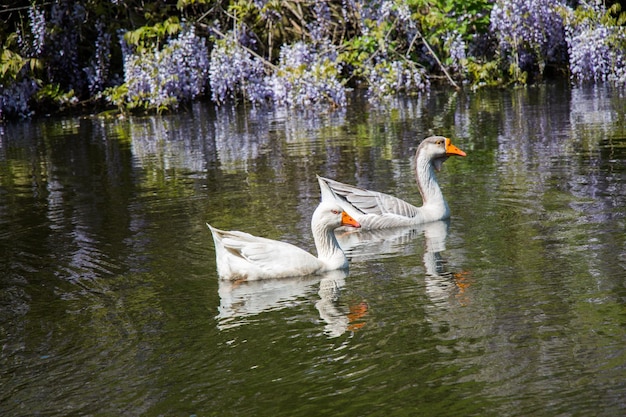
[0,0,626,119]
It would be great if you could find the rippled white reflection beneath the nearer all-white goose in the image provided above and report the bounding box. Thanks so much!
[216,270,367,337]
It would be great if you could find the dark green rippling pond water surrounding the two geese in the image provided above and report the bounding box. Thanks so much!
[0,85,626,416]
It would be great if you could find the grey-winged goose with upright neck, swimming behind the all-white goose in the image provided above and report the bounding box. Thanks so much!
[317,136,466,229]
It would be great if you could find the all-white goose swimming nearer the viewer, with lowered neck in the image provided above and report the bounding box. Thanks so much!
[207,202,360,280]
